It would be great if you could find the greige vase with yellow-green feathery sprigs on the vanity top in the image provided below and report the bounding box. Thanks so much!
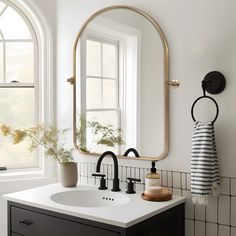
[0,124,78,187]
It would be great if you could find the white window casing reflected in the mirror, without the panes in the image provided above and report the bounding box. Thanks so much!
[77,17,142,152]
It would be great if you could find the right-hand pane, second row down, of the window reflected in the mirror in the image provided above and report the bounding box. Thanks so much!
[103,79,117,108]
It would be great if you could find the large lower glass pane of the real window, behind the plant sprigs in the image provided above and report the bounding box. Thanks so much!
[0,88,38,169]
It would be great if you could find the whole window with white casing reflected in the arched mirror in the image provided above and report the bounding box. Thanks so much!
[78,17,141,154]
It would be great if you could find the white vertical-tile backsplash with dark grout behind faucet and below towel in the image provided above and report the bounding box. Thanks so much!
[78,162,236,236]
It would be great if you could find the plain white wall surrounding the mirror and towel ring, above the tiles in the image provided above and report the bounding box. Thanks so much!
[57,0,236,177]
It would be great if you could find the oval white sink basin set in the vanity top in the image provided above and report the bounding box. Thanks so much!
[51,190,130,207]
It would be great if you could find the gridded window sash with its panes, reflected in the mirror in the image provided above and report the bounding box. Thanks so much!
[82,37,120,153]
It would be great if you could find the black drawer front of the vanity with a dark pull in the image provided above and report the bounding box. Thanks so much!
[10,206,120,236]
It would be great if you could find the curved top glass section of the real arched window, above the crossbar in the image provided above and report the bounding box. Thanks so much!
[0,7,32,39]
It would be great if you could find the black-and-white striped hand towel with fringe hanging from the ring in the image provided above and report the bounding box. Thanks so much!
[191,121,220,205]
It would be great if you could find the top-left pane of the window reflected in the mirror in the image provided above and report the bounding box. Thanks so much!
[86,40,101,76]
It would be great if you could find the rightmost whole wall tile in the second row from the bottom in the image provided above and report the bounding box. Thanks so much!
[218,196,230,225]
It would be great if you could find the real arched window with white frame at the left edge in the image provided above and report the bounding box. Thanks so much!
[0,0,51,172]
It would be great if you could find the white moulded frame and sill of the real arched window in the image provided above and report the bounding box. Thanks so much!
[0,0,55,181]
